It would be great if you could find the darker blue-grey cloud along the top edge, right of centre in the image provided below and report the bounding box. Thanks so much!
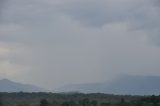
[59,0,154,27]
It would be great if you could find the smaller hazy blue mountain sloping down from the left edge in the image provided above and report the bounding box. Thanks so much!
[0,79,47,92]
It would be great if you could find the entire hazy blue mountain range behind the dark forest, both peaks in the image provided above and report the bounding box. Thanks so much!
[0,75,160,95]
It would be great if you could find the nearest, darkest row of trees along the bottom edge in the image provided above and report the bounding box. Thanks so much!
[39,95,160,106]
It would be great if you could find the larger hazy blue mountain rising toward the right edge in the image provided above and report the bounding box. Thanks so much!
[55,75,160,95]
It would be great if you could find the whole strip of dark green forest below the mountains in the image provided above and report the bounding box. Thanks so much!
[0,92,160,106]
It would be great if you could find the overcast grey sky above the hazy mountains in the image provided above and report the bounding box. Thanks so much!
[0,0,160,89]
